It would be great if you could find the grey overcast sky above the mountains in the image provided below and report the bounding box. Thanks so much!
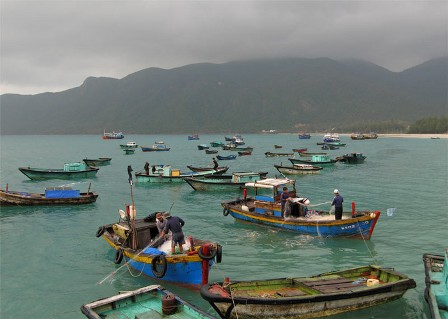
[0,0,448,94]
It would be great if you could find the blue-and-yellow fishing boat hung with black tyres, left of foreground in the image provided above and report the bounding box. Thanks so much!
[96,205,222,286]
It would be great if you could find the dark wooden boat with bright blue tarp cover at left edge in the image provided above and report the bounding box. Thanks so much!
[0,184,98,206]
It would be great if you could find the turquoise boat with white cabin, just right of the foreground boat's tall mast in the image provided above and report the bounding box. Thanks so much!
[135,164,221,183]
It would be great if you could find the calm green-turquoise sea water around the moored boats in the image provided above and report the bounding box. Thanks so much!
[0,134,448,319]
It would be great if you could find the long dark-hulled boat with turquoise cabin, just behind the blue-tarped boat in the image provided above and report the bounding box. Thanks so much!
[19,162,99,180]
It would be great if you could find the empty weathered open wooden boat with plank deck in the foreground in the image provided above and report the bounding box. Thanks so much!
[201,265,416,319]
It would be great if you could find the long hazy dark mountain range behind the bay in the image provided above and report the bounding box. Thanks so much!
[0,57,448,134]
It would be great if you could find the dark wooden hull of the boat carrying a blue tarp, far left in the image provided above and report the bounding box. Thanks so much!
[0,190,98,206]
